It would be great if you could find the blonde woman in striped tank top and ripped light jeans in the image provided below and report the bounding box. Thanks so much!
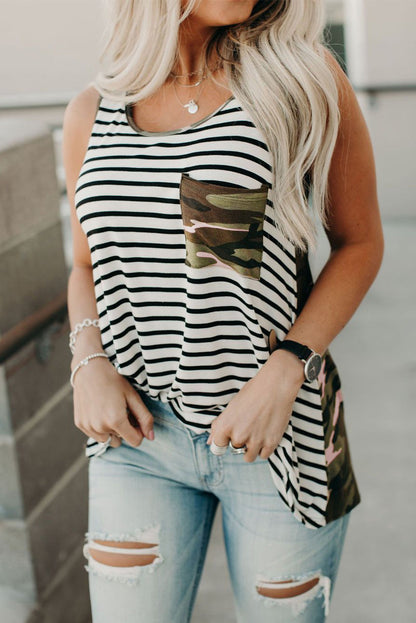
[64,0,383,623]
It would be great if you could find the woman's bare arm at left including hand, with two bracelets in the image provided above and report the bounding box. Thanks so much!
[63,87,153,447]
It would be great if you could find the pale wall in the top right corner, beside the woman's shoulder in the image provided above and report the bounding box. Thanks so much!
[345,0,416,217]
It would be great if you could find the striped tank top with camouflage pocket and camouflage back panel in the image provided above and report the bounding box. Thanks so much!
[75,96,360,528]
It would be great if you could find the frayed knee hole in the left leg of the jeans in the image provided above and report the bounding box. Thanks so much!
[83,527,163,584]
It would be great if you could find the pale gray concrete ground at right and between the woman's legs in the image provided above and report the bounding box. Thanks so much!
[192,218,416,623]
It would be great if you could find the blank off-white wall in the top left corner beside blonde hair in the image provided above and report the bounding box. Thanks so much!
[0,0,102,105]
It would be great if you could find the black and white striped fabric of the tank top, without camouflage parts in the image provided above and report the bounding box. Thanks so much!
[75,97,328,528]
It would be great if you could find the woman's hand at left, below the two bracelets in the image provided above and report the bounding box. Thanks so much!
[73,357,154,447]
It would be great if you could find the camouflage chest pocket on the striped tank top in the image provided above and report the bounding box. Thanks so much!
[179,173,268,279]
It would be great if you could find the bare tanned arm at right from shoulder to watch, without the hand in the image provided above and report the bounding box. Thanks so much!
[272,54,384,365]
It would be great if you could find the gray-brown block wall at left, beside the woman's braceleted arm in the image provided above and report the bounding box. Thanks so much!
[0,118,90,623]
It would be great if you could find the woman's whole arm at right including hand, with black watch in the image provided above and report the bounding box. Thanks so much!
[208,53,384,462]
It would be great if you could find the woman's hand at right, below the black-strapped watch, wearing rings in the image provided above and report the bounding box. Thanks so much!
[207,350,305,462]
